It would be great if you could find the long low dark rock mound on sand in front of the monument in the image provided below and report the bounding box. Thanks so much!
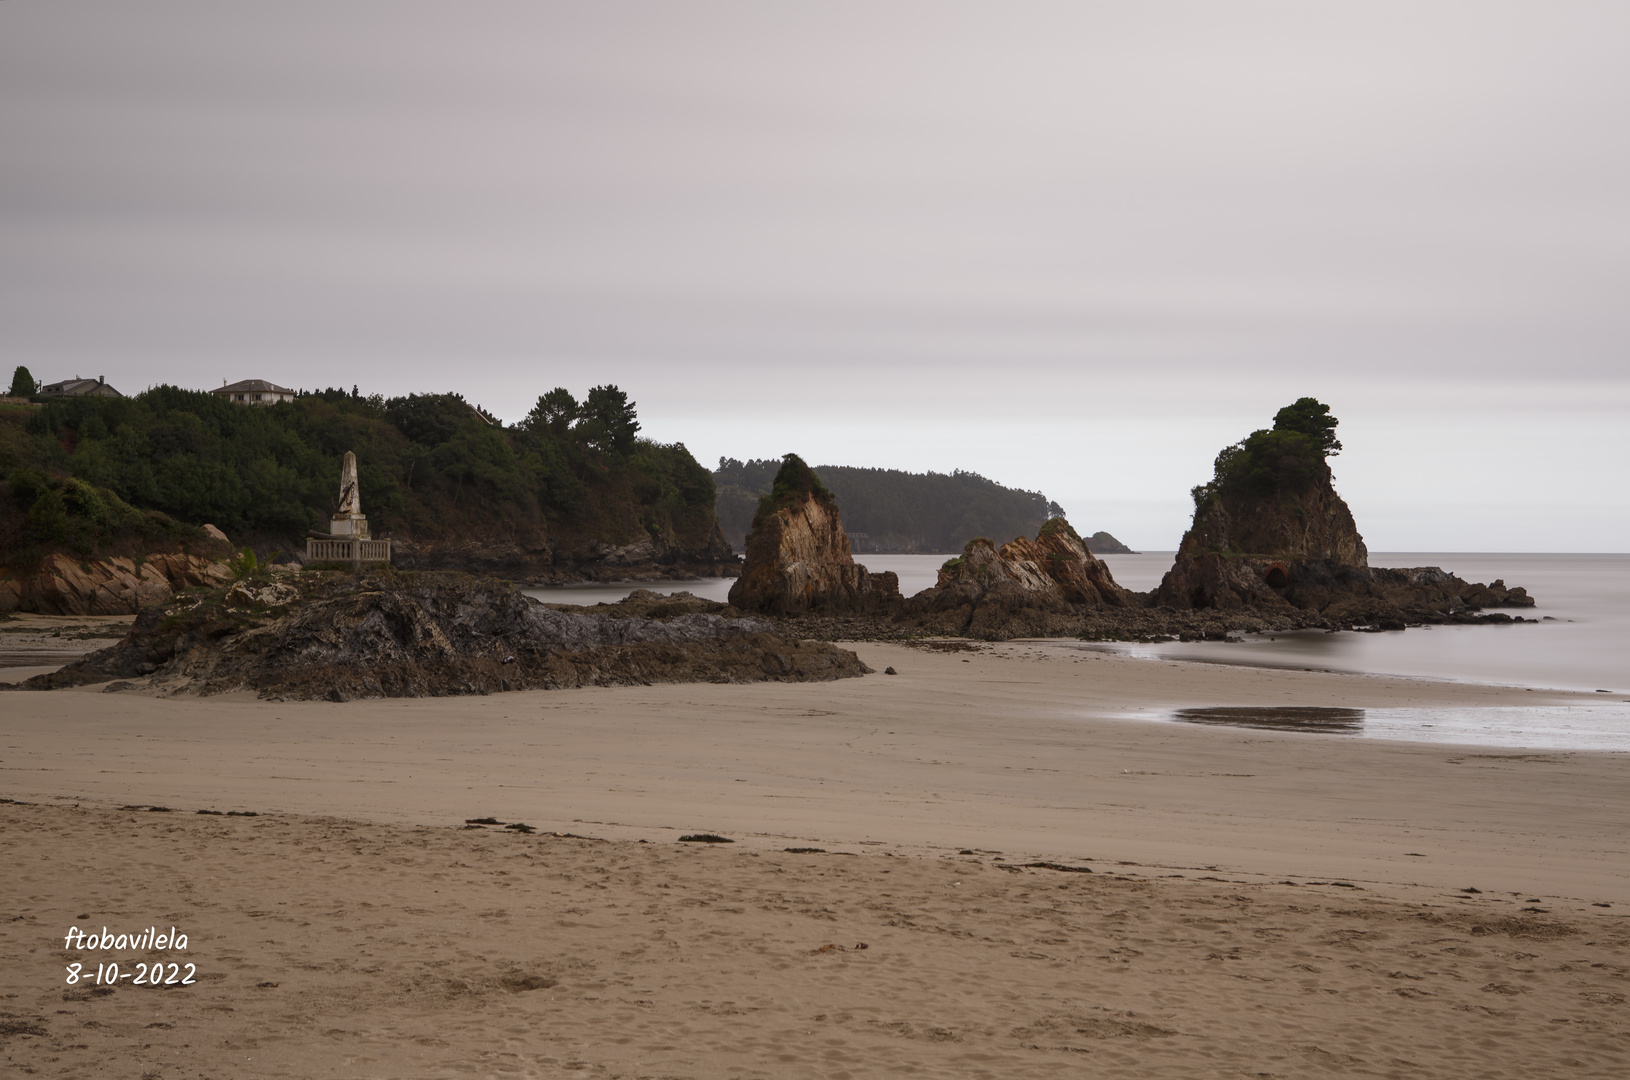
[23,570,869,700]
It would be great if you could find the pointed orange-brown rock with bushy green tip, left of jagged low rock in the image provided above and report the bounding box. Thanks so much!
[730,454,900,616]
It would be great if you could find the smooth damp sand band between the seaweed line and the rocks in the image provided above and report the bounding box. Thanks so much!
[0,642,1630,904]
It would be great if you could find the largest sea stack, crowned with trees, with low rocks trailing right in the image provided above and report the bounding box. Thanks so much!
[1154,397,1534,627]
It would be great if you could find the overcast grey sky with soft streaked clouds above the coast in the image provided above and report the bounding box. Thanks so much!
[0,0,1630,551]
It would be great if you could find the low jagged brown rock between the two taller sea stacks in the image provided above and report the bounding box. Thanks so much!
[900,518,1138,637]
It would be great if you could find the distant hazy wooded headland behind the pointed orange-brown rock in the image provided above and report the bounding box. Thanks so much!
[714,458,1063,552]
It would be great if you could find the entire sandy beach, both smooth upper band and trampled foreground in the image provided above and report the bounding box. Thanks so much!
[0,643,1630,1078]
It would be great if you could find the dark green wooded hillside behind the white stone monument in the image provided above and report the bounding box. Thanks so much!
[0,386,725,570]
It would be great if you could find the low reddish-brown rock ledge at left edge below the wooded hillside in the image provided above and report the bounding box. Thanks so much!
[0,552,231,616]
